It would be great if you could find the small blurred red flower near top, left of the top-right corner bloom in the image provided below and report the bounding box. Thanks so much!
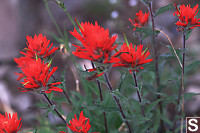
[129,10,149,30]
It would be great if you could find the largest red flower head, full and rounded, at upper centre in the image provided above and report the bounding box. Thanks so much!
[70,22,117,63]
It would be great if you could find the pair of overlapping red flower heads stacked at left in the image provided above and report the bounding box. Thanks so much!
[14,34,63,93]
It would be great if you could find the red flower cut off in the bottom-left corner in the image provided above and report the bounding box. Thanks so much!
[0,112,22,133]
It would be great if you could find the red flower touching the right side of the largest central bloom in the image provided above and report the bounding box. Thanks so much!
[111,43,153,72]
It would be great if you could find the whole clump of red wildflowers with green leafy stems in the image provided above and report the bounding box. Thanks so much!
[10,0,200,133]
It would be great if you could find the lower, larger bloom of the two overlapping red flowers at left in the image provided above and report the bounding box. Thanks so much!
[15,58,63,93]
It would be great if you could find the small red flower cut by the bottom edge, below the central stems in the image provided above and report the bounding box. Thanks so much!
[67,111,91,133]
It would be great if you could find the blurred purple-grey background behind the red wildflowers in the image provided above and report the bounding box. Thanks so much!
[0,0,200,131]
